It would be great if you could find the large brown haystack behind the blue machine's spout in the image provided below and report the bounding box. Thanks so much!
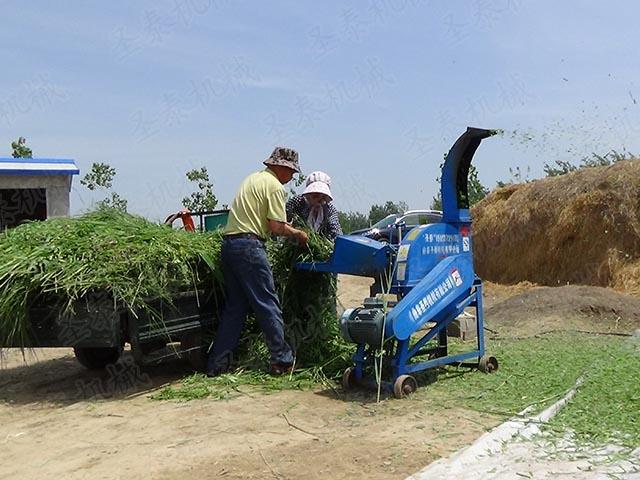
[472,160,640,294]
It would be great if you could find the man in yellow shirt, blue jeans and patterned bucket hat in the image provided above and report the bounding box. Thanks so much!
[207,147,308,376]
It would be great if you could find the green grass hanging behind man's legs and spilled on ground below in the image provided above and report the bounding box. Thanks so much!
[157,232,353,400]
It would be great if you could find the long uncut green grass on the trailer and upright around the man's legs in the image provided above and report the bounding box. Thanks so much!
[0,209,346,374]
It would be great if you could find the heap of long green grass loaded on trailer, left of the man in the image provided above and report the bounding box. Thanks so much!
[0,209,222,347]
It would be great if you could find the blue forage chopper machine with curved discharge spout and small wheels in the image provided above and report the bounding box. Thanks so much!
[297,127,498,398]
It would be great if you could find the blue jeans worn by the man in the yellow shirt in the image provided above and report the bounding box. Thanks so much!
[207,238,293,373]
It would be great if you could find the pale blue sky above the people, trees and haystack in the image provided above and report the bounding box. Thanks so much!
[0,0,640,219]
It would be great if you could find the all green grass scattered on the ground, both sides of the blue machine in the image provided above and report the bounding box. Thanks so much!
[153,333,640,447]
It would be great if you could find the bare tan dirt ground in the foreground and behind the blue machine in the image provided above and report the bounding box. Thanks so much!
[0,277,640,479]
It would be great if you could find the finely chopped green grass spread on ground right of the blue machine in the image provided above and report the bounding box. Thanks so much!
[419,333,640,448]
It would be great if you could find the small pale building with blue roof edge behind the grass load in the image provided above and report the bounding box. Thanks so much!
[0,158,80,230]
